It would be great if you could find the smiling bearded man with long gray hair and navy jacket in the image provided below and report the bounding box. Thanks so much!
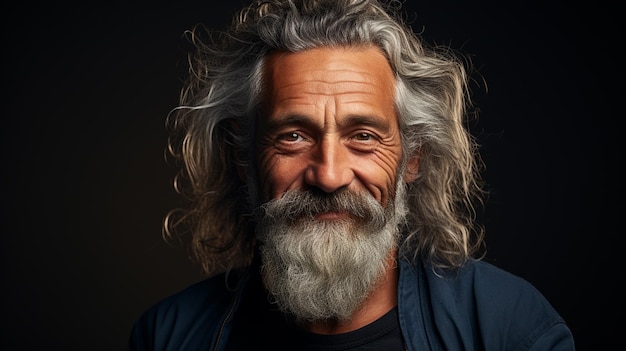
[129,0,574,351]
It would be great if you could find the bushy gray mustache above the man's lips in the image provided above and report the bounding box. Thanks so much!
[257,188,385,222]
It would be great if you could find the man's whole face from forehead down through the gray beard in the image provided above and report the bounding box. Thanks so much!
[251,48,406,321]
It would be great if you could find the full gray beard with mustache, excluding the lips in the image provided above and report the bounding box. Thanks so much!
[257,181,406,322]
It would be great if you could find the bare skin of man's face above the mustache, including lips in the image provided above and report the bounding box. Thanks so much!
[257,47,402,209]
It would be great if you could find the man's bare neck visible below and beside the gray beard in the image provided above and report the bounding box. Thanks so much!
[304,256,398,334]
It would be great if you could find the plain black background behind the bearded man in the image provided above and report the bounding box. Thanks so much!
[0,0,624,350]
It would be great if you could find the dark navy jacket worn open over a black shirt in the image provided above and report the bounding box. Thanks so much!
[129,260,574,351]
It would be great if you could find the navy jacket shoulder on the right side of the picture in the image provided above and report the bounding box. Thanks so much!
[402,261,574,350]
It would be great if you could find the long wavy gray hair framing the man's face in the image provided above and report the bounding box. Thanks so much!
[163,0,485,275]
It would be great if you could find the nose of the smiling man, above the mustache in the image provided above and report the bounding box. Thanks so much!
[304,140,354,193]
